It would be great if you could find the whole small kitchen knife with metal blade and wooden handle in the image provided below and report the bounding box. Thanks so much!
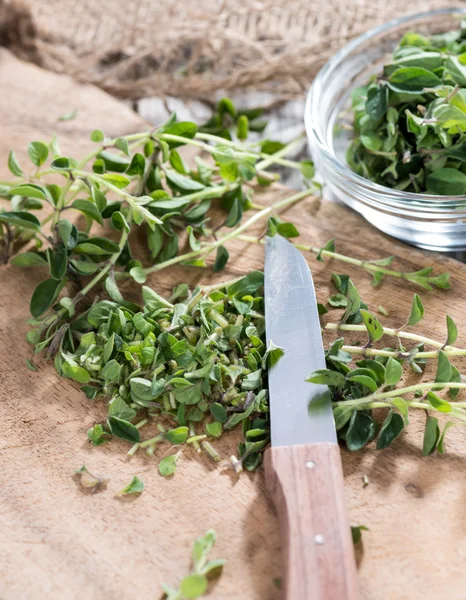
[264,235,358,600]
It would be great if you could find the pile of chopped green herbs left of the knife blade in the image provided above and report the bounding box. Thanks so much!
[64,272,274,475]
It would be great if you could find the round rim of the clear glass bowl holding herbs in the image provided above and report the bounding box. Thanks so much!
[304,7,466,212]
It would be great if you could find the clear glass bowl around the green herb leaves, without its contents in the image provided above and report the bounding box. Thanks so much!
[305,8,466,252]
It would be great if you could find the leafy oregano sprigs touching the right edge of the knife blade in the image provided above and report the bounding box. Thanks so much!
[314,276,466,454]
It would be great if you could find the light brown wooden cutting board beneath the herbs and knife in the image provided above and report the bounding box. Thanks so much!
[0,51,466,600]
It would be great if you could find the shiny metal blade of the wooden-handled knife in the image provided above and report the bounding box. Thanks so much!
[264,235,337,446]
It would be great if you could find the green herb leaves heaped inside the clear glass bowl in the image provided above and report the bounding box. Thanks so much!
[347,26,466,195]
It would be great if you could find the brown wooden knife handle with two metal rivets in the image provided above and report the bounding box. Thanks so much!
[265,443,358,600]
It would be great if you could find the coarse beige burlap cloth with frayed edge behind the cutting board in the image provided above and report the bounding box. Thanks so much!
[0,0,462,101]
